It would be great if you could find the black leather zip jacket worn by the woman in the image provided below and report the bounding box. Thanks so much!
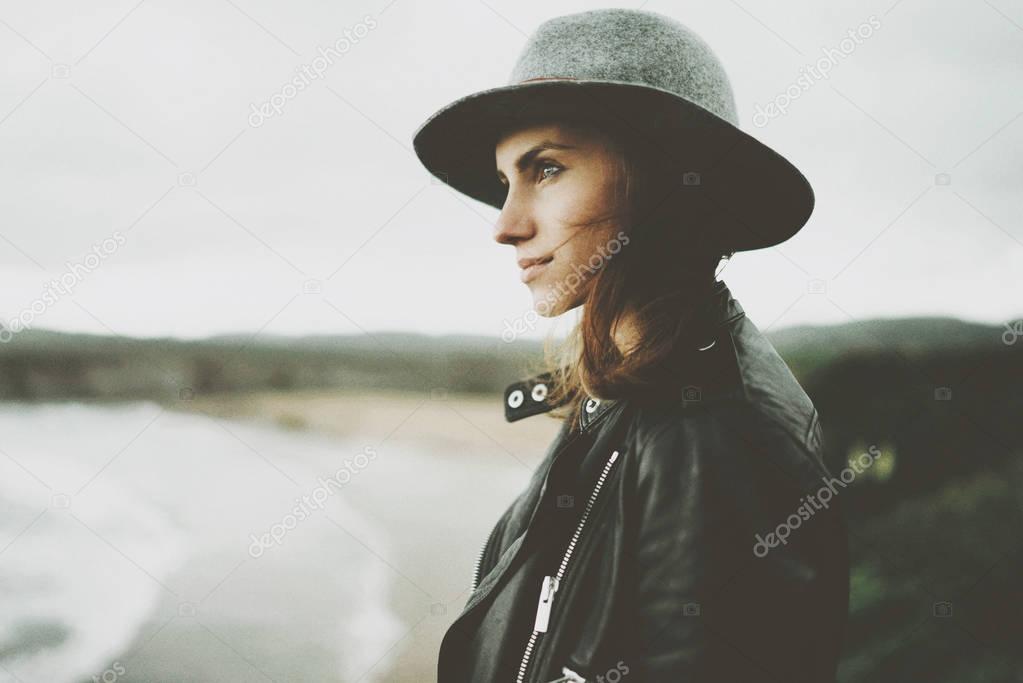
[438,281,849,683]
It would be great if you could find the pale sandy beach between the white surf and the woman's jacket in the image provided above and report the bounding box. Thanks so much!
[168,391,560,683]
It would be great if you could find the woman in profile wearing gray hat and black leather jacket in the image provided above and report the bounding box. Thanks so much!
[415,9,848,683]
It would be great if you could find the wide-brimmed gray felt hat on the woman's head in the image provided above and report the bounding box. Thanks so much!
[413,9,813,252]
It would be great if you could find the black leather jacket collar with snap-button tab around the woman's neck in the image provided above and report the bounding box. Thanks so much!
[504,280,746,431]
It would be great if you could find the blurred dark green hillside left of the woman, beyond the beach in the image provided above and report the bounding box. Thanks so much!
[0,330,541,400]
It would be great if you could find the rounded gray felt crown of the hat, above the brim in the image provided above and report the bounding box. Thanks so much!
[509,9,739,127]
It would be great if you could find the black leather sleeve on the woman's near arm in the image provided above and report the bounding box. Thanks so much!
[626,417,847,683]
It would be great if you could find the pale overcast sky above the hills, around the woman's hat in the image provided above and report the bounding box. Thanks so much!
[0,0,1023,337]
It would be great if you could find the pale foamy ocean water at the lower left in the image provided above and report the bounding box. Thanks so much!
[0,402,408,683]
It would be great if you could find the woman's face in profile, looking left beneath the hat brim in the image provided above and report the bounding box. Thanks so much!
[494,124,628,317]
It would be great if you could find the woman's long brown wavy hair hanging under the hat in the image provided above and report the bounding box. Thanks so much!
[519,113,733,429]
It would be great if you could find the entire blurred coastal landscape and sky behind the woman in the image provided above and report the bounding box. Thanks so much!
[0,0,1023,683]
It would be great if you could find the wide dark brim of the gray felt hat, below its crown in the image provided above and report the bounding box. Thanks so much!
[413,80,814,252]
